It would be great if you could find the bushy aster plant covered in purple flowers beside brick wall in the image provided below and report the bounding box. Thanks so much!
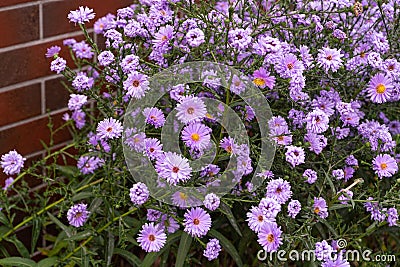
[0,0,400,266]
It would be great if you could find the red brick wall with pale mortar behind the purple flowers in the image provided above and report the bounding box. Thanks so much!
[0,0,133,183]
